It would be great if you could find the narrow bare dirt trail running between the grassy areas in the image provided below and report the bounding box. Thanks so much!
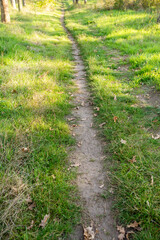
[61,10,117,240]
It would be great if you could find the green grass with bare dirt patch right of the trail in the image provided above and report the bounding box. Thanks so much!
[66,2,160,240]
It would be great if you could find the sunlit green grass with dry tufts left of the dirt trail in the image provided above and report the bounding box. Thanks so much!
[0,2,79,240]
